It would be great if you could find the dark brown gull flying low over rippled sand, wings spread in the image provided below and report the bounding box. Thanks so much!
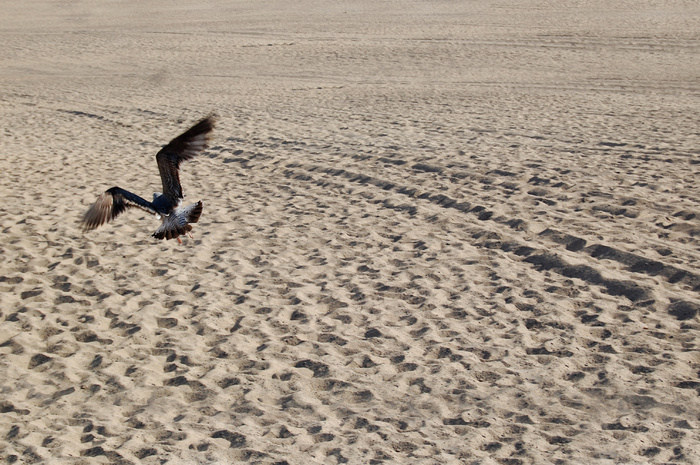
[81,116,214,244]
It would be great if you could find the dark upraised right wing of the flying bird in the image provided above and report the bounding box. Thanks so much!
[156,116,214,207]
